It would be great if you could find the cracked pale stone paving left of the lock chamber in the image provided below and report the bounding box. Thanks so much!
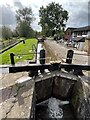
[0,76,34,119]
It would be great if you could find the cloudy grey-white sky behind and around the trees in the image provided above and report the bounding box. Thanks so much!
[0,0,90,31]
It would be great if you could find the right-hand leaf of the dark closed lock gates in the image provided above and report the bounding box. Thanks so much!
[53,77,76,100]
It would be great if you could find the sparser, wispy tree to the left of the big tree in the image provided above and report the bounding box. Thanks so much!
[16,7,33,37]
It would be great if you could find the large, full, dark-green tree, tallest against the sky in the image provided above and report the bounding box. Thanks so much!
[39,2,68,35]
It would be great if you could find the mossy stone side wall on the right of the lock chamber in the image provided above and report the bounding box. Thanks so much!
[71,80,90,120]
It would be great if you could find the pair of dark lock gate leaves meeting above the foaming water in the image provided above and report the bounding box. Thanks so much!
[35,72,76,102]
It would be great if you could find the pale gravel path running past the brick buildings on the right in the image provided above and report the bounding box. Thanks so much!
[45,40,90,65]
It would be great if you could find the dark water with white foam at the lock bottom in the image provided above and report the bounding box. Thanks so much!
[36,97,76,120]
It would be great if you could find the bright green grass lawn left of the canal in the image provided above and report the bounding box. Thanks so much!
[0,39,37,64]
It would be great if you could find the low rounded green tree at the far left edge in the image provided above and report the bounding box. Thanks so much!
[2,26,12,40]
